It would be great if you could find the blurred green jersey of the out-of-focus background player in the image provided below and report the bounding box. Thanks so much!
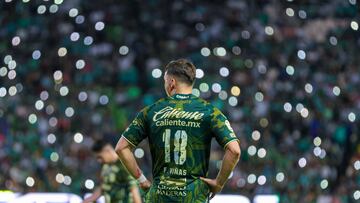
[101,161,137,203]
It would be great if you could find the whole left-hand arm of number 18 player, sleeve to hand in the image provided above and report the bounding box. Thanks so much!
[115,108,151,190]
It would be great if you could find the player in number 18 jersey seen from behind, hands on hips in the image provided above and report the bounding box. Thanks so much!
[115,59,240,203]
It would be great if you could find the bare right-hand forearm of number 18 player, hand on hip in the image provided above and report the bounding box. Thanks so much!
[201,141,241,198]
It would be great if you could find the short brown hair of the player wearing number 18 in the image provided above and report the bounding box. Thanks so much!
[165,59,196,85]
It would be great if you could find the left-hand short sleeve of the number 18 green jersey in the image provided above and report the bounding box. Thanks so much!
[122,108,147,147]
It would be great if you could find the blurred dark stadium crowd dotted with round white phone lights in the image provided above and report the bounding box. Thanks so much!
[0,0,360,202]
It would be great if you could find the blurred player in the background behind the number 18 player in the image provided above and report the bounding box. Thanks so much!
[84,140,141,203]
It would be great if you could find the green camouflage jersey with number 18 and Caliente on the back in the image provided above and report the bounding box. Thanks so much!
[122,94,238,202]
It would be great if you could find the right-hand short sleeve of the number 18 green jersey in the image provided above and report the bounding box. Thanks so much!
[210,107,240,149]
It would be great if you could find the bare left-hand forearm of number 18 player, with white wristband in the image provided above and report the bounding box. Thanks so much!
[115,137,151,190]
